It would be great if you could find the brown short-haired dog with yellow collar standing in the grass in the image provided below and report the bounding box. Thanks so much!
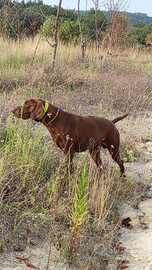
[13,98,128,174]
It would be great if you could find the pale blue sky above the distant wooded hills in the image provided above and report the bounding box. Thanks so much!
[43,0,152,17]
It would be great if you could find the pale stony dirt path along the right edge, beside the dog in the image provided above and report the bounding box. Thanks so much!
[118,110,152,270]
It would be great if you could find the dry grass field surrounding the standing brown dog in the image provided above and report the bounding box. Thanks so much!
[0,39,152,269]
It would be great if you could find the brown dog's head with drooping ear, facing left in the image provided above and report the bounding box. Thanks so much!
[12,98,44,120]
